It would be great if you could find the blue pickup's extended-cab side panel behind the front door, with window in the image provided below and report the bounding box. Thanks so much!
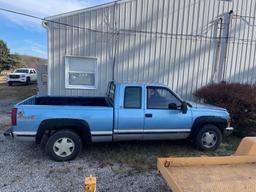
[114,86,144,141]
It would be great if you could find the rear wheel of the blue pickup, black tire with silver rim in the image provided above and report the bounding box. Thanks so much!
[45,130,82,161]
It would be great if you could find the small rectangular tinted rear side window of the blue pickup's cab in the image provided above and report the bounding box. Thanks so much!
[124,87,141,109]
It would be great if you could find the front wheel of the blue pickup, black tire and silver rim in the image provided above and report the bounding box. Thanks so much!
[195,124,222,151]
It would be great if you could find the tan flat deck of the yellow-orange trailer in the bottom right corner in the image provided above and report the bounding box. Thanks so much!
[165,163,256,192]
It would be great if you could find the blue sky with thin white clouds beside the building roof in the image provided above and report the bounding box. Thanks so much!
[0,0,112,58]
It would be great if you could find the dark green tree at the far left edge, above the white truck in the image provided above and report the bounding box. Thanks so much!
[0,40,11,71]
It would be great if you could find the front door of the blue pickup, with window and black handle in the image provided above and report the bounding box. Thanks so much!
[143,86,192,140]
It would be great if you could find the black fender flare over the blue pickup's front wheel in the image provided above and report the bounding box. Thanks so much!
[189,116,228,139]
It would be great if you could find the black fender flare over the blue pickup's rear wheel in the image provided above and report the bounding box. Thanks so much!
[36,119,91,144]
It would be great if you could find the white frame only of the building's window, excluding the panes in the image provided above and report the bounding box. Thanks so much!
[65,55,98,89]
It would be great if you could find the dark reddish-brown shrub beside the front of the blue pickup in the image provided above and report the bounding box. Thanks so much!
[194,82,256,137]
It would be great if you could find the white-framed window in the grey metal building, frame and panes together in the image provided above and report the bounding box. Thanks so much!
[65,56,97,89]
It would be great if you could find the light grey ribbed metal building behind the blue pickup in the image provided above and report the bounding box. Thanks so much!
[43,0,256,98]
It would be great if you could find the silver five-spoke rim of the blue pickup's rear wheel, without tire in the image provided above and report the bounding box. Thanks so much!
[53,137,75,157]
